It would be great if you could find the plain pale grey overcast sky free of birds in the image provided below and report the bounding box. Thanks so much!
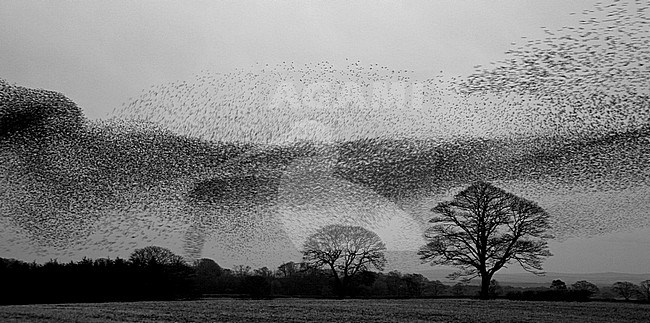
[0,0,650,273]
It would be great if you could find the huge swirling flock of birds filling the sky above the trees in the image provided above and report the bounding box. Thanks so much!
[0,0,650,265]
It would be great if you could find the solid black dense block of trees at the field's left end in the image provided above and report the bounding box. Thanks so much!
[0,249,194,304]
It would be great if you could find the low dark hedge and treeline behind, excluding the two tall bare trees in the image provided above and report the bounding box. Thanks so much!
[0,246,647,304]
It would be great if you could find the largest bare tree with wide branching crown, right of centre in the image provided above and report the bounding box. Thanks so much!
[419,182,552,299]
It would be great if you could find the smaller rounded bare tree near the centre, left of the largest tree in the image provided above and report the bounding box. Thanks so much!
[303,225,386,297]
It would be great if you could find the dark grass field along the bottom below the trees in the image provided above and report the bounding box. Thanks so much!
[0,299,650,323]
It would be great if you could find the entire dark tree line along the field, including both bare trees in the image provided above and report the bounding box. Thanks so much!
[0,182,650,304]
